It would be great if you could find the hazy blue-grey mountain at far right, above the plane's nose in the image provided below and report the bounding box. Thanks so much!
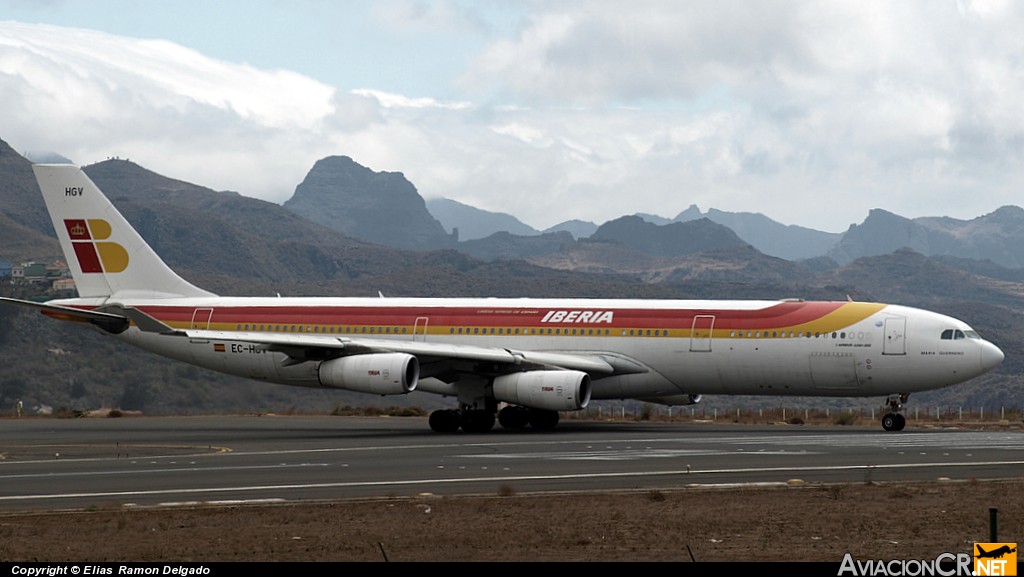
[828,206,1024,269]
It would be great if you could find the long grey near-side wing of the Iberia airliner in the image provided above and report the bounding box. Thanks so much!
[174,330,622,376]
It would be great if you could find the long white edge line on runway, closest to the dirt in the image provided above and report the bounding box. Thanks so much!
[0,461,1024,502]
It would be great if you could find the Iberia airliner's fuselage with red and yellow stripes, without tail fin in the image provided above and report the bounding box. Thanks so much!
[63,297,1002,404]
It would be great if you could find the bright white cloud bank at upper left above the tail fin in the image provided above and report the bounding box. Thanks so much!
[0,23,337,199]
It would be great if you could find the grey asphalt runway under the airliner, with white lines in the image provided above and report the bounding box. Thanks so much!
[0,416,1024,511]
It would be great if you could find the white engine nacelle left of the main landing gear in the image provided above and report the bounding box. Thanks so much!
[318,353,420,395]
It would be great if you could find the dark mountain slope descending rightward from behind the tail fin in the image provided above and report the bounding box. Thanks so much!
[74,160,423,294]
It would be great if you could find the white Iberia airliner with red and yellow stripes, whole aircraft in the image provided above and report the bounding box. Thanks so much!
[3,165,1002,431]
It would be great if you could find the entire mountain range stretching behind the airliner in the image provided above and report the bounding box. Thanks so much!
[0,140,1024,412]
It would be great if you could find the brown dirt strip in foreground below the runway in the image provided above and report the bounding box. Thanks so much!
[0,480,1024,564]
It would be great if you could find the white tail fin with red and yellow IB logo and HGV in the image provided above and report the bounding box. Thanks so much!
[32,164,215,298]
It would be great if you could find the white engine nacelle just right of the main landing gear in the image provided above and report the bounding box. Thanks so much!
[494,371,590,411]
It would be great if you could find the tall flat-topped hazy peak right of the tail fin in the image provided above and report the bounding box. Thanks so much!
[284,156,454,250]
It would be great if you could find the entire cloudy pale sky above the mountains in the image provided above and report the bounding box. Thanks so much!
[0,0,1024,233]
